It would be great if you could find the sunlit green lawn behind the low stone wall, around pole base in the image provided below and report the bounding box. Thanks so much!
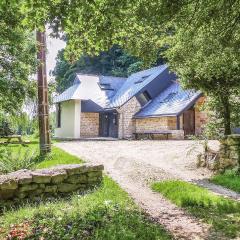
[0,138,83,173]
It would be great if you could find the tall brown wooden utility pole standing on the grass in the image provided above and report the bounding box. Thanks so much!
[36,30,51,155]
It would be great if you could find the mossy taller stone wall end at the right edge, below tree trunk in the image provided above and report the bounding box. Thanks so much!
[219,134,240,169]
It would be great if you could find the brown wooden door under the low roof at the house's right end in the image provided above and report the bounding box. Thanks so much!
[183,108,195,136]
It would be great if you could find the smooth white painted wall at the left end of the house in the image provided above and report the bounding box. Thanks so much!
[55,100,81,138]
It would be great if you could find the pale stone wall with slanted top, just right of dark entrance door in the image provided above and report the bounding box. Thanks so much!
[118,97,141,139]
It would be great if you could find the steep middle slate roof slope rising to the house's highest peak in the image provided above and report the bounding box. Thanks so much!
[108,64,167,108]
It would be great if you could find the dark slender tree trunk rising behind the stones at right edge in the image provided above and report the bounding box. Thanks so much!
[220,93,232,135]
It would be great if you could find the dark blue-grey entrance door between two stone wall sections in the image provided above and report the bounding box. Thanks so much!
[99,112,118,138]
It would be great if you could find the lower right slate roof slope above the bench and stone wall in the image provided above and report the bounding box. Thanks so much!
[134,82,202,118]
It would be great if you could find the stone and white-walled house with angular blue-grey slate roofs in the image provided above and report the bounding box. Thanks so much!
[54,65,207,139]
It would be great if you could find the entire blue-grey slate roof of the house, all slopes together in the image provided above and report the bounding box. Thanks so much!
[54,65,201,118]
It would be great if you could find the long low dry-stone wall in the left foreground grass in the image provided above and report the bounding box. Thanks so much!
[0,164,103,200]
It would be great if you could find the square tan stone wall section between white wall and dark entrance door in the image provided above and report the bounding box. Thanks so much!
[80,112,99,137]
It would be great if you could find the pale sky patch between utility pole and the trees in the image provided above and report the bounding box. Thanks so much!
[46,30,66,81]
